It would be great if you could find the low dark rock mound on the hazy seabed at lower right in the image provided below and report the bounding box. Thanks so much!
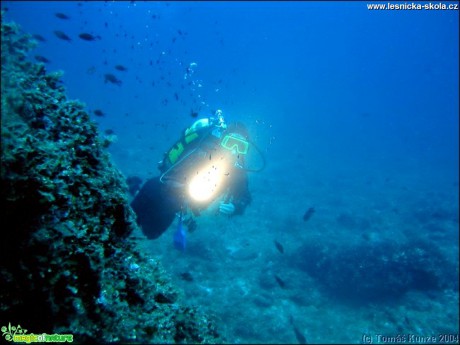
[292,236,458,304]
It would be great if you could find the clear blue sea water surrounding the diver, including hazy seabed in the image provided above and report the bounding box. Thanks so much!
[2,1,459,343]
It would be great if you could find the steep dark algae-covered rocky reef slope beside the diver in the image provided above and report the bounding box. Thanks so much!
[0,16,222,343]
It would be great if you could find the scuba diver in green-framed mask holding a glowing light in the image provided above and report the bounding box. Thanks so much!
[131,110,265,243]
